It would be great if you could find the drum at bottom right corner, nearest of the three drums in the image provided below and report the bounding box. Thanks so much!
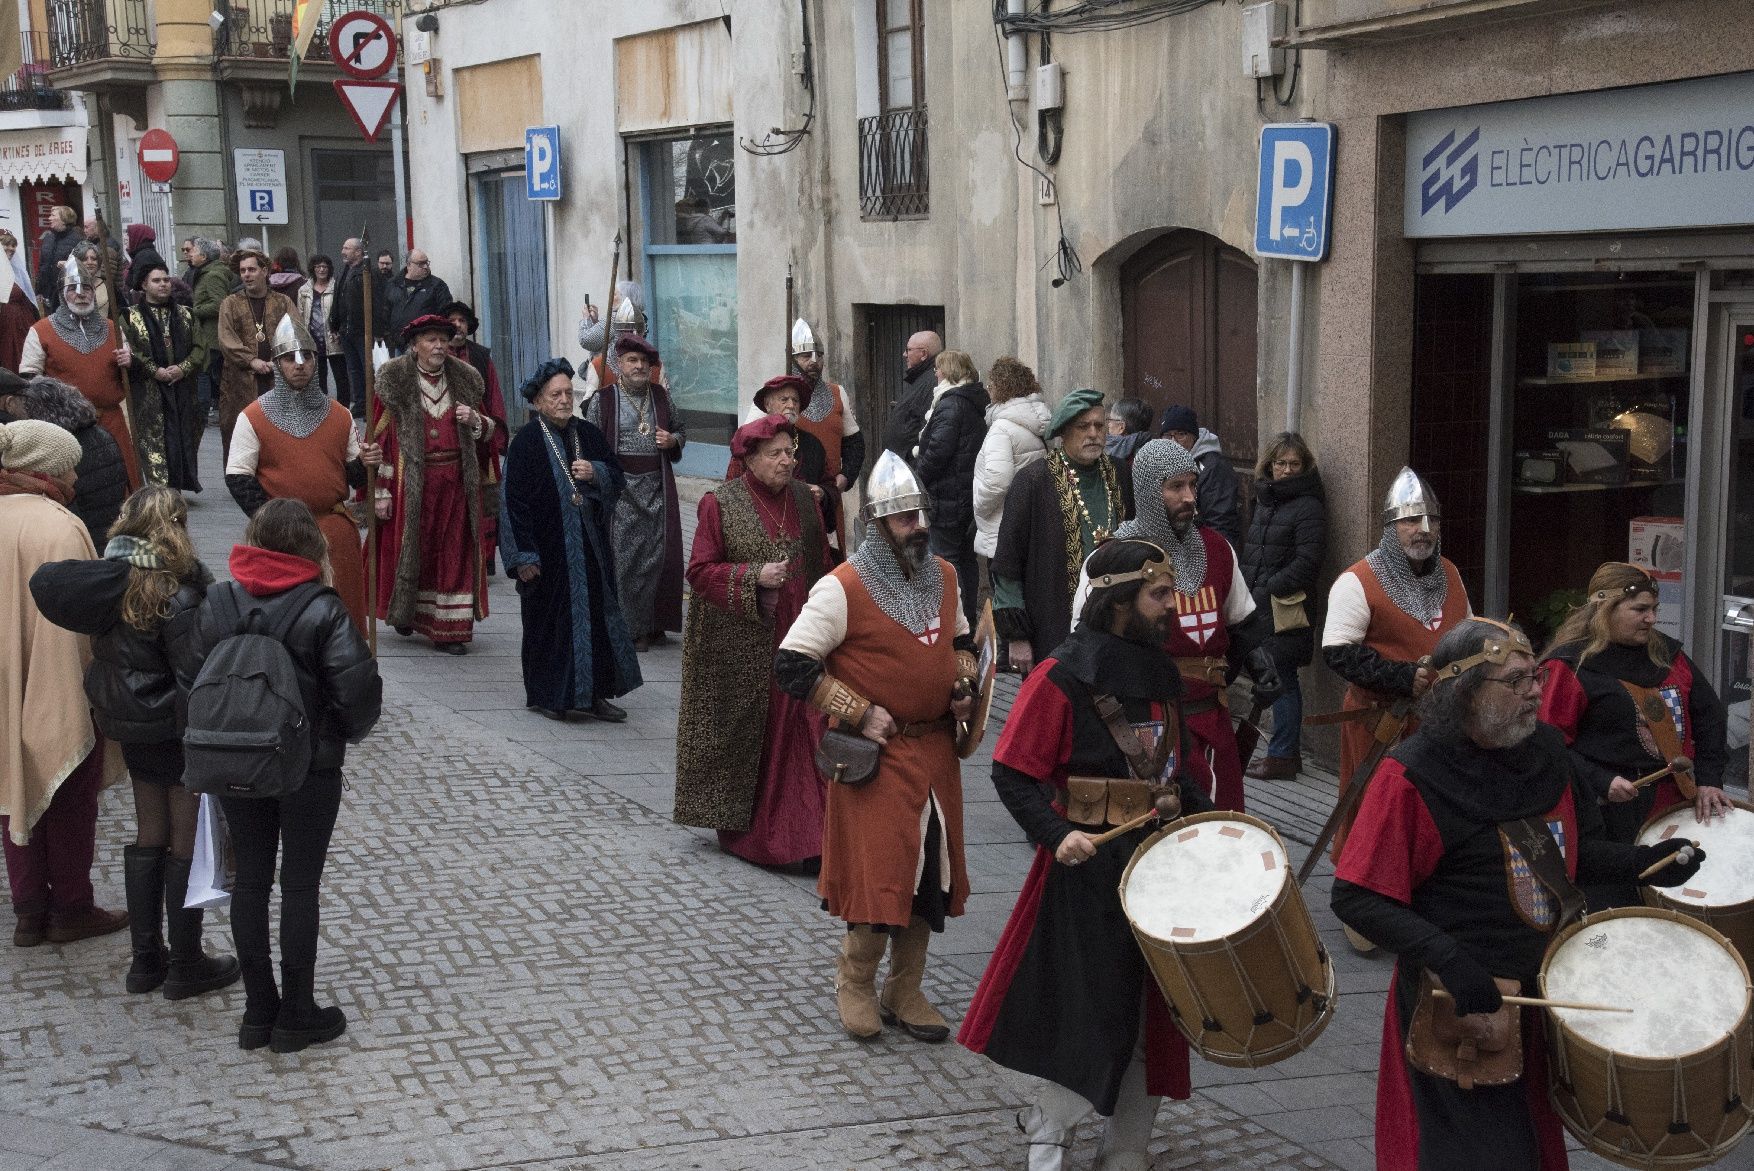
[1540,906,1754,1167]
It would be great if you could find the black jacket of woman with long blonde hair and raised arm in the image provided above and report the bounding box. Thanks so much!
[30,561,210,743]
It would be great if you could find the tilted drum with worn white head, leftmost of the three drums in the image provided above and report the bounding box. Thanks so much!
[1121,812,1335,1068]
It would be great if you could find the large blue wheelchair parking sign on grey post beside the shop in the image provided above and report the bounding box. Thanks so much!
[1254,123,1333,431]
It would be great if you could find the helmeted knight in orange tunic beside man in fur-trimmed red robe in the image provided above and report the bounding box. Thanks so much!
[225,316,365,633]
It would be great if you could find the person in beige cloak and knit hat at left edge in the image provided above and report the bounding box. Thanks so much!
[0,419,128,947]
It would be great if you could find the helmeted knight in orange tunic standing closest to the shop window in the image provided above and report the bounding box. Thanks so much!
[1321,468,1472,950]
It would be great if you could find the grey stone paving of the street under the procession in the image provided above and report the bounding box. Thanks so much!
[0,432,1641,1171]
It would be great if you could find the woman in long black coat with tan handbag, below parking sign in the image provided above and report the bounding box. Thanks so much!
[1242,431,1328,780]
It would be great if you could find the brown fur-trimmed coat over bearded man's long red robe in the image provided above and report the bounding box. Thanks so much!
[372,354,491,626]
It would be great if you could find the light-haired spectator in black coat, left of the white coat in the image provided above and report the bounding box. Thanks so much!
[914,349,989,628]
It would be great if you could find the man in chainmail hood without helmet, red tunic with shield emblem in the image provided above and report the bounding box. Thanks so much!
[1077,438,1280,812]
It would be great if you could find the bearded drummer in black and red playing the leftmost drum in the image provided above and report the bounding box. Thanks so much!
[958,540,1212,1171]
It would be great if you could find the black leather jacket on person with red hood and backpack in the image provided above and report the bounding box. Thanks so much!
[177,587,384,770]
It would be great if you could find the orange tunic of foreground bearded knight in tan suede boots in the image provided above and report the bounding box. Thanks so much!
[816,561,968,927]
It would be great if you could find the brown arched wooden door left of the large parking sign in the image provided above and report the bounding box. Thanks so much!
[1121,228,1258,466]
